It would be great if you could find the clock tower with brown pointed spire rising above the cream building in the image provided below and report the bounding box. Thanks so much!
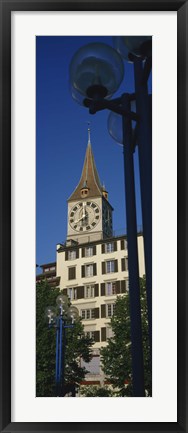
[67,128,113,243]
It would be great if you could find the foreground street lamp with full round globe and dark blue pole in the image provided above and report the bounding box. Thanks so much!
[70,40,150,397]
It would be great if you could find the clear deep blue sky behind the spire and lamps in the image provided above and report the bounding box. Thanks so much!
[36,36,151,265]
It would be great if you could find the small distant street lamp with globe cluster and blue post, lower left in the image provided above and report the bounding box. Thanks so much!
[45,294,79,397]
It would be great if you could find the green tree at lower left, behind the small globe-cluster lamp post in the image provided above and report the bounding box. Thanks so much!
[36,281,93,397]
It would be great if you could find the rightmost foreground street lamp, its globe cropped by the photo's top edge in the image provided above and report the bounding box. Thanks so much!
[113,36,152,360]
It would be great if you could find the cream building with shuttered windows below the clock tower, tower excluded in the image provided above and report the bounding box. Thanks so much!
[57,235,145,383]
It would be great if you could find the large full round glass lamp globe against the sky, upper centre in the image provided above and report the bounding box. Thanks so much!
[69,43,124,99]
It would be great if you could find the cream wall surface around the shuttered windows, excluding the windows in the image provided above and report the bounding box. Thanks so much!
[57,236,145,349]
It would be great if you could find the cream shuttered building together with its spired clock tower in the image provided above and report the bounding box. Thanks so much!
[56,129,145,383]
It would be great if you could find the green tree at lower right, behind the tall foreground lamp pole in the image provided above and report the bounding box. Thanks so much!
[100,277,151,397]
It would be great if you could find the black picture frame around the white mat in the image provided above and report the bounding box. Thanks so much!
[0,0,188,433]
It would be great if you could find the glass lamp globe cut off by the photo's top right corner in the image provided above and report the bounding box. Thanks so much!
[115,36,152,60]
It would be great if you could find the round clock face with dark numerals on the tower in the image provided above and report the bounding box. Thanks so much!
[69,201,100,232]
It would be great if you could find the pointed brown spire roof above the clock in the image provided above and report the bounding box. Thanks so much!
[68,129,103,200]
